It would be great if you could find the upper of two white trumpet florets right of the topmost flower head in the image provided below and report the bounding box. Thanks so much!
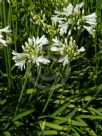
[82,13,97,27]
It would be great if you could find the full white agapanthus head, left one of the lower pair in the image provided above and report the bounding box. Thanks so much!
[12,35,50,70]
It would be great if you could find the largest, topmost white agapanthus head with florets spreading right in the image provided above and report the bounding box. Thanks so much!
[52,2,97,35]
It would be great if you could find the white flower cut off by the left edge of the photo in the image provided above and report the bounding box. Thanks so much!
[0,26,11,46]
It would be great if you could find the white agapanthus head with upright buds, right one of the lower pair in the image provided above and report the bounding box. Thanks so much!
[51,36,85,66]
